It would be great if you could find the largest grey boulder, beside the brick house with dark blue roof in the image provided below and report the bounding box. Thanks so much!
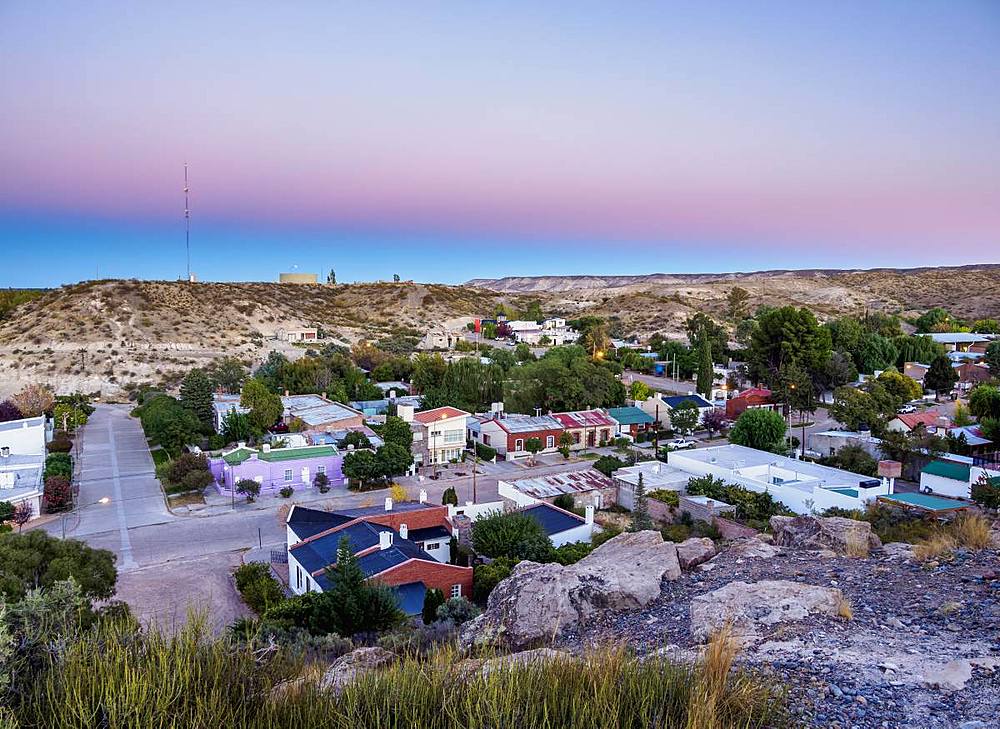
[461,531,681,650]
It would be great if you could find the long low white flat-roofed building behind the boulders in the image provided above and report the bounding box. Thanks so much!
[667,444,891,514]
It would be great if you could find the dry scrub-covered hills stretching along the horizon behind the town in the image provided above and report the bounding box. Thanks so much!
[0,266,1000,397]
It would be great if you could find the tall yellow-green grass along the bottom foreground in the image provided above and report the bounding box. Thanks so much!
[13,620,786,729]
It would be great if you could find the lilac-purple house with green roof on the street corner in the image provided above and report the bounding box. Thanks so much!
[209,443,344,496]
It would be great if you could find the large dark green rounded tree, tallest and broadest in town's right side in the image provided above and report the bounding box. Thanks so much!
[747,306,832,386]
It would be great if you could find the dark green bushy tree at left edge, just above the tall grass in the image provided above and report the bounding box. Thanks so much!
[0,529,118,602]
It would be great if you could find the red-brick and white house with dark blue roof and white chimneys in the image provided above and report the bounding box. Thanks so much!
[285,499,472,615]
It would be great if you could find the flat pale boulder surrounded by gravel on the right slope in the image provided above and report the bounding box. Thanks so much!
[691,580,844,641]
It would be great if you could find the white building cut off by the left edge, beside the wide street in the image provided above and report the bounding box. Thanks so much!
[0,416,46,516]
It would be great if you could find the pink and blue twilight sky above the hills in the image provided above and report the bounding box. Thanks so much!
[0,0,1000,287]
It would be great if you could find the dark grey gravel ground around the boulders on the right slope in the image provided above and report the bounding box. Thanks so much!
[563,536,1000,729]
